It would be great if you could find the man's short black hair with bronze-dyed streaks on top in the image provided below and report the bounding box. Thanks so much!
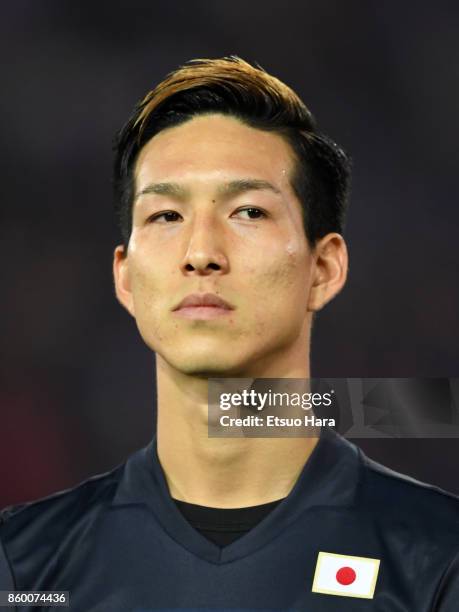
[114,56,350,249]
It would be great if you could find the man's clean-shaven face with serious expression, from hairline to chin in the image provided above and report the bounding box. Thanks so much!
[115,114,324,376]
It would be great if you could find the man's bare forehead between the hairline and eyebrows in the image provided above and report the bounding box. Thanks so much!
[135,114,294,190]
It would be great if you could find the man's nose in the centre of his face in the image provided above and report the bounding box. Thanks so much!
[181,216,229,276]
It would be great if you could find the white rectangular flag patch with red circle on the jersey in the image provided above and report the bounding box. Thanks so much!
[312,552,379,599]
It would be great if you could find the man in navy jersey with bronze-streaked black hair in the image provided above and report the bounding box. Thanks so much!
[0,58,459,612]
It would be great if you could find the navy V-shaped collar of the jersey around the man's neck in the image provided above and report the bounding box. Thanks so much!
[112,428,360,564]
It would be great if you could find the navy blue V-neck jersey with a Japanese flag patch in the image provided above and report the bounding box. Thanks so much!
[0,429,459,612]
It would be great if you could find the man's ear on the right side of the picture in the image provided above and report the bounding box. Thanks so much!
[308,233,348,312]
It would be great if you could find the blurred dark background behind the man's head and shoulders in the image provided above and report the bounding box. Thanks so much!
[0,0,459,506]
